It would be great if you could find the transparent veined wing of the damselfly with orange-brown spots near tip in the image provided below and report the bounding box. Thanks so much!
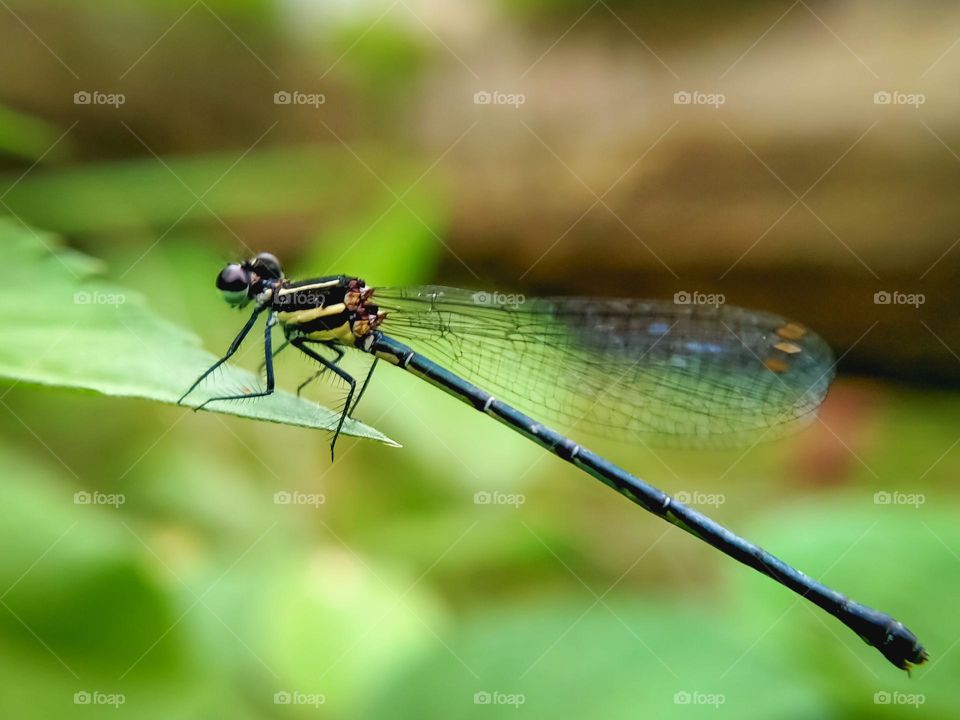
[375,286,834,446]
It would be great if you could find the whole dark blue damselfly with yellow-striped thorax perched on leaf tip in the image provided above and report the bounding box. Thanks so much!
[179,253,928,672]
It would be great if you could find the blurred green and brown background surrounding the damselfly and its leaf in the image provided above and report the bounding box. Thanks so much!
[0,0,960,719]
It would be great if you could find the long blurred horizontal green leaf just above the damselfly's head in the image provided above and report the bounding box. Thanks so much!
[4,147,412,233]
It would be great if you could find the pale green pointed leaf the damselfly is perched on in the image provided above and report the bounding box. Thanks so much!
[0,219,396,444]
